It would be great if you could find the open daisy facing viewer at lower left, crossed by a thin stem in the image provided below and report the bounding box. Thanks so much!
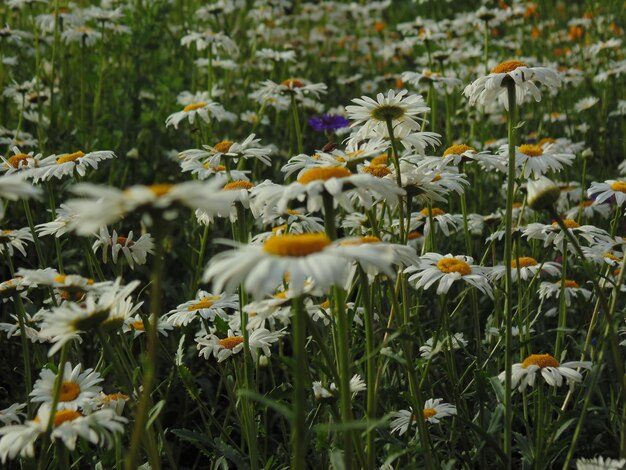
[30,362,104,410]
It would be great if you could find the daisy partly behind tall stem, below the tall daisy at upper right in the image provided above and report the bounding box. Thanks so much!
[500,144,575,178]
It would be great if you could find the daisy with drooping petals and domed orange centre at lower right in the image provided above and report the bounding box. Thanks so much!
[498,354,591,392]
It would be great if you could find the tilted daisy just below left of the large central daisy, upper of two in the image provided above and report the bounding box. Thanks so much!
[164,290,239,326]
